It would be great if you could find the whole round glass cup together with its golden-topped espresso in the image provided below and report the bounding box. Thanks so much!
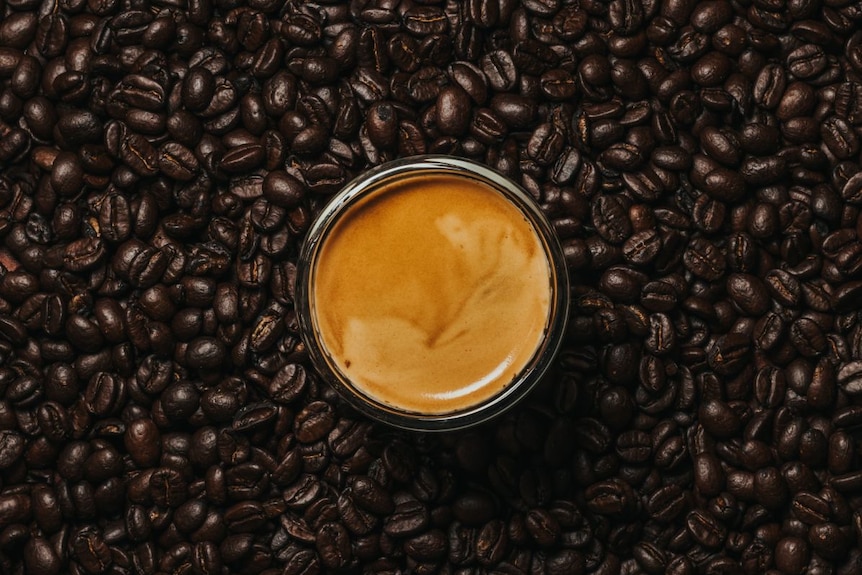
[296,156,569,431]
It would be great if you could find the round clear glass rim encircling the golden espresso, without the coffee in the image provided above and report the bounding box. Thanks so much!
[296,155,569,431]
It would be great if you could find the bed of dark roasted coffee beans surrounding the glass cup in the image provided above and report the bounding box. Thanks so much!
[0,0,862,575]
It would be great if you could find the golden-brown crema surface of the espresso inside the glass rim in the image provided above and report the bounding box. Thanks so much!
[311,174,553,414]
